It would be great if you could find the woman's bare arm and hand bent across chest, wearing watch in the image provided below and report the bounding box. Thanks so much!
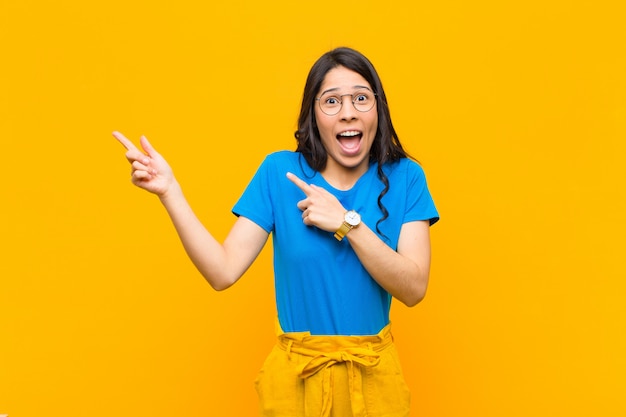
[287,173,430,306]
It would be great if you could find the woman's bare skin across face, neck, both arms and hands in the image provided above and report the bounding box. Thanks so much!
[113,67,430,306]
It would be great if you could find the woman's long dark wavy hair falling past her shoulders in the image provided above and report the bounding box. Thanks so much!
[295,47,409,236]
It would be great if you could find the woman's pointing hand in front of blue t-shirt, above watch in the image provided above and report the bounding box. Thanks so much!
[287,172,346,232]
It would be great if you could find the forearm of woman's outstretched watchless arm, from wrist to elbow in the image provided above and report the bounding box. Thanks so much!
[159,183,239,290]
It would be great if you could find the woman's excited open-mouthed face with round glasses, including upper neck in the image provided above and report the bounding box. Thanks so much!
[315,67,378,175]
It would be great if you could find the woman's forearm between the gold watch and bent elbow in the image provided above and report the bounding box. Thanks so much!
[347,223,430,307]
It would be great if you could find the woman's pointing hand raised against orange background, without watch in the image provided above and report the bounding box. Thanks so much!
[113,132,176,198]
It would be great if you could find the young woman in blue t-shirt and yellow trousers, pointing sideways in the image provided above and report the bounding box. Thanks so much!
[114,48,439,417]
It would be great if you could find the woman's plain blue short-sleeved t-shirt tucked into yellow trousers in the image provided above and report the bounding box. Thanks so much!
[233,151,439,335]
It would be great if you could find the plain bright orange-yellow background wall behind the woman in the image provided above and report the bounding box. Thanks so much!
[0,0,626,417]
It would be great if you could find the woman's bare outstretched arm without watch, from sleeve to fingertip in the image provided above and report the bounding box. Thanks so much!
[113,132,268,290]
